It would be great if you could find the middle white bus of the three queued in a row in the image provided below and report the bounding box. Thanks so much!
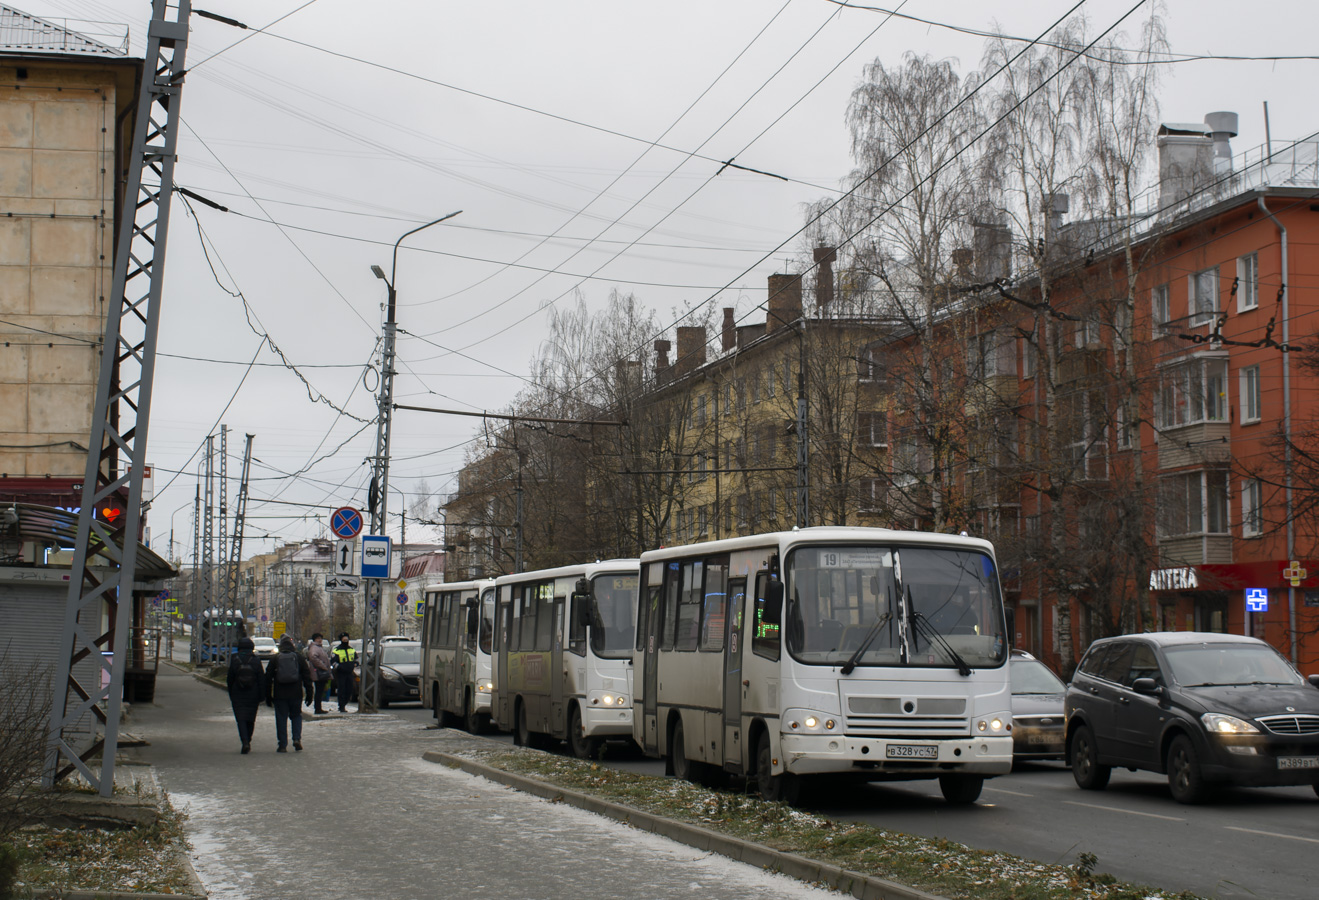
[493,560,638,759]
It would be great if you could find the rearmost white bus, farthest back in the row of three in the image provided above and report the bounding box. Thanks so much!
[421,578,495,734]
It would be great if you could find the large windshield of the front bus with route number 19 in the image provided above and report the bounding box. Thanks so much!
[783,545,1008,670]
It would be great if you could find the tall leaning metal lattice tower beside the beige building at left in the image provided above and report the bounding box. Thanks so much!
[44,0,193,797]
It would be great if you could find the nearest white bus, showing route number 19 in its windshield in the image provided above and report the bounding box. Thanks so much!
[632,528,1012,802]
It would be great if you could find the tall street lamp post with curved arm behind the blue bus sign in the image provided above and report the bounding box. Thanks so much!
[357,210,462,713]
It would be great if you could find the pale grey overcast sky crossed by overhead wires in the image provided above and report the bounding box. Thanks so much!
[7,0,1319,560]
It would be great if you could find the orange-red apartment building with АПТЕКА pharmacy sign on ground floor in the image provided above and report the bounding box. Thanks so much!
[889,113,1319,673]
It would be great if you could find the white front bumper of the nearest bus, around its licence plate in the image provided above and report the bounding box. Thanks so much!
[780,734,1012,777]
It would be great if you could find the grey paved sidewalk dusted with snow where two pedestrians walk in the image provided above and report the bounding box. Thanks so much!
[131,665,839,900]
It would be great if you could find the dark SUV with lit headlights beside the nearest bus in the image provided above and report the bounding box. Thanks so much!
[1064,632,1319,804]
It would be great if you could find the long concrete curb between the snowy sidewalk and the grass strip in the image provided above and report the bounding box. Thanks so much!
[422,750,944,900]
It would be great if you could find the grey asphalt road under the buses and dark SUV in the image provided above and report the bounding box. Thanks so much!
[393,706,1319,900]
